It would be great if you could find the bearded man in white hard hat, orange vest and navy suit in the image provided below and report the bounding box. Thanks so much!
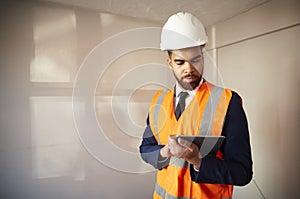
[140,13,253,199]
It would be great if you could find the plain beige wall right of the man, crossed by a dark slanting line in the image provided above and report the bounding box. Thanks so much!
[209,0,300,199]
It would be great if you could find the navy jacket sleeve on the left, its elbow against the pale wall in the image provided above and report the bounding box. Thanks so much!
[140,116,170,170]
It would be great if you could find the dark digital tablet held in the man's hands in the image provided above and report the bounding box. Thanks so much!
[176,135,225,157]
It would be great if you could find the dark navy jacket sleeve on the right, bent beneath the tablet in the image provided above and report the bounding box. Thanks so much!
[190,93,253,186]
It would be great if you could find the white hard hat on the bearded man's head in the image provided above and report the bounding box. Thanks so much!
[160,12,207,50]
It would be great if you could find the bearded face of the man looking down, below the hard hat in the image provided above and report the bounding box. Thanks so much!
[168,46,203,90]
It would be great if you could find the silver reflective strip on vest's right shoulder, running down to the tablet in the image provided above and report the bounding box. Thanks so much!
[199,86,224,135]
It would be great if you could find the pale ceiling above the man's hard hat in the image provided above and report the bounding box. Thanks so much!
[40,0,270,26]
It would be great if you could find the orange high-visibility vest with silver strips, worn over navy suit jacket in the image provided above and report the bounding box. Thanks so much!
[149,82,233,199]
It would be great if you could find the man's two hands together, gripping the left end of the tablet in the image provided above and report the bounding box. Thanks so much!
[160,135,201,169]
